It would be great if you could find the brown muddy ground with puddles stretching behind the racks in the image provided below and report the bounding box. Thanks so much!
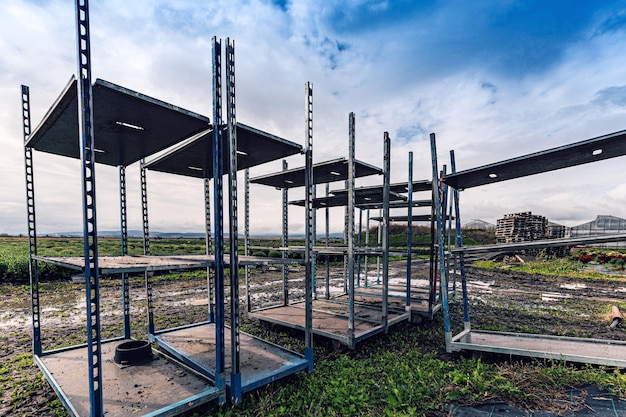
[0,262,626,416]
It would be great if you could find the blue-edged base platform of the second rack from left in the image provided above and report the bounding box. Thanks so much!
[152,323,309,397]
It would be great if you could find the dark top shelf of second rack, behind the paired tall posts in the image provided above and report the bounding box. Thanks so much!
[145,123,303,178]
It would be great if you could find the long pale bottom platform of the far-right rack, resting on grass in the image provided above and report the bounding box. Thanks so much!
[450,330,626,368]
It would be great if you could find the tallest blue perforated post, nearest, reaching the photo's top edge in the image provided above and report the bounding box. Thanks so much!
[76,0,104,417]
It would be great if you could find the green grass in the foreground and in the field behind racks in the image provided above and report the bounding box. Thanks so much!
[0,238,626,416]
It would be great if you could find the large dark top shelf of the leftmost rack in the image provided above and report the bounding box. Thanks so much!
[25,77,210,166]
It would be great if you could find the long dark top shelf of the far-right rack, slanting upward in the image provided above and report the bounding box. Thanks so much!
[443,130,626,190]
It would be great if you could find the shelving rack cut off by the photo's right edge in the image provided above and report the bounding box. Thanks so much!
[431,127,626,367]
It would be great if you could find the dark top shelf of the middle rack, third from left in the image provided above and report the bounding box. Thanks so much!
[250,158,383,188]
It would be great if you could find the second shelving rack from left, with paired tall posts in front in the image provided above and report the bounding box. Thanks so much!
[140,38,313,404]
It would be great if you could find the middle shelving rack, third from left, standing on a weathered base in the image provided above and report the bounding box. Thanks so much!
[248,109,402,348]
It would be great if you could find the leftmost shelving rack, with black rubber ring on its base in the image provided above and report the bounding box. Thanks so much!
[22,0,220,417]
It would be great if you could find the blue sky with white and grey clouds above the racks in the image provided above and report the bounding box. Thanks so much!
[0,0,626,234]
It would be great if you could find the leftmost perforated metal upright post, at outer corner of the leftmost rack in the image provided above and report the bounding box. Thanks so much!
[22,85,42,355]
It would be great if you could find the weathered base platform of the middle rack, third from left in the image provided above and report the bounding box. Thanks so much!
[248,295,411,348]
